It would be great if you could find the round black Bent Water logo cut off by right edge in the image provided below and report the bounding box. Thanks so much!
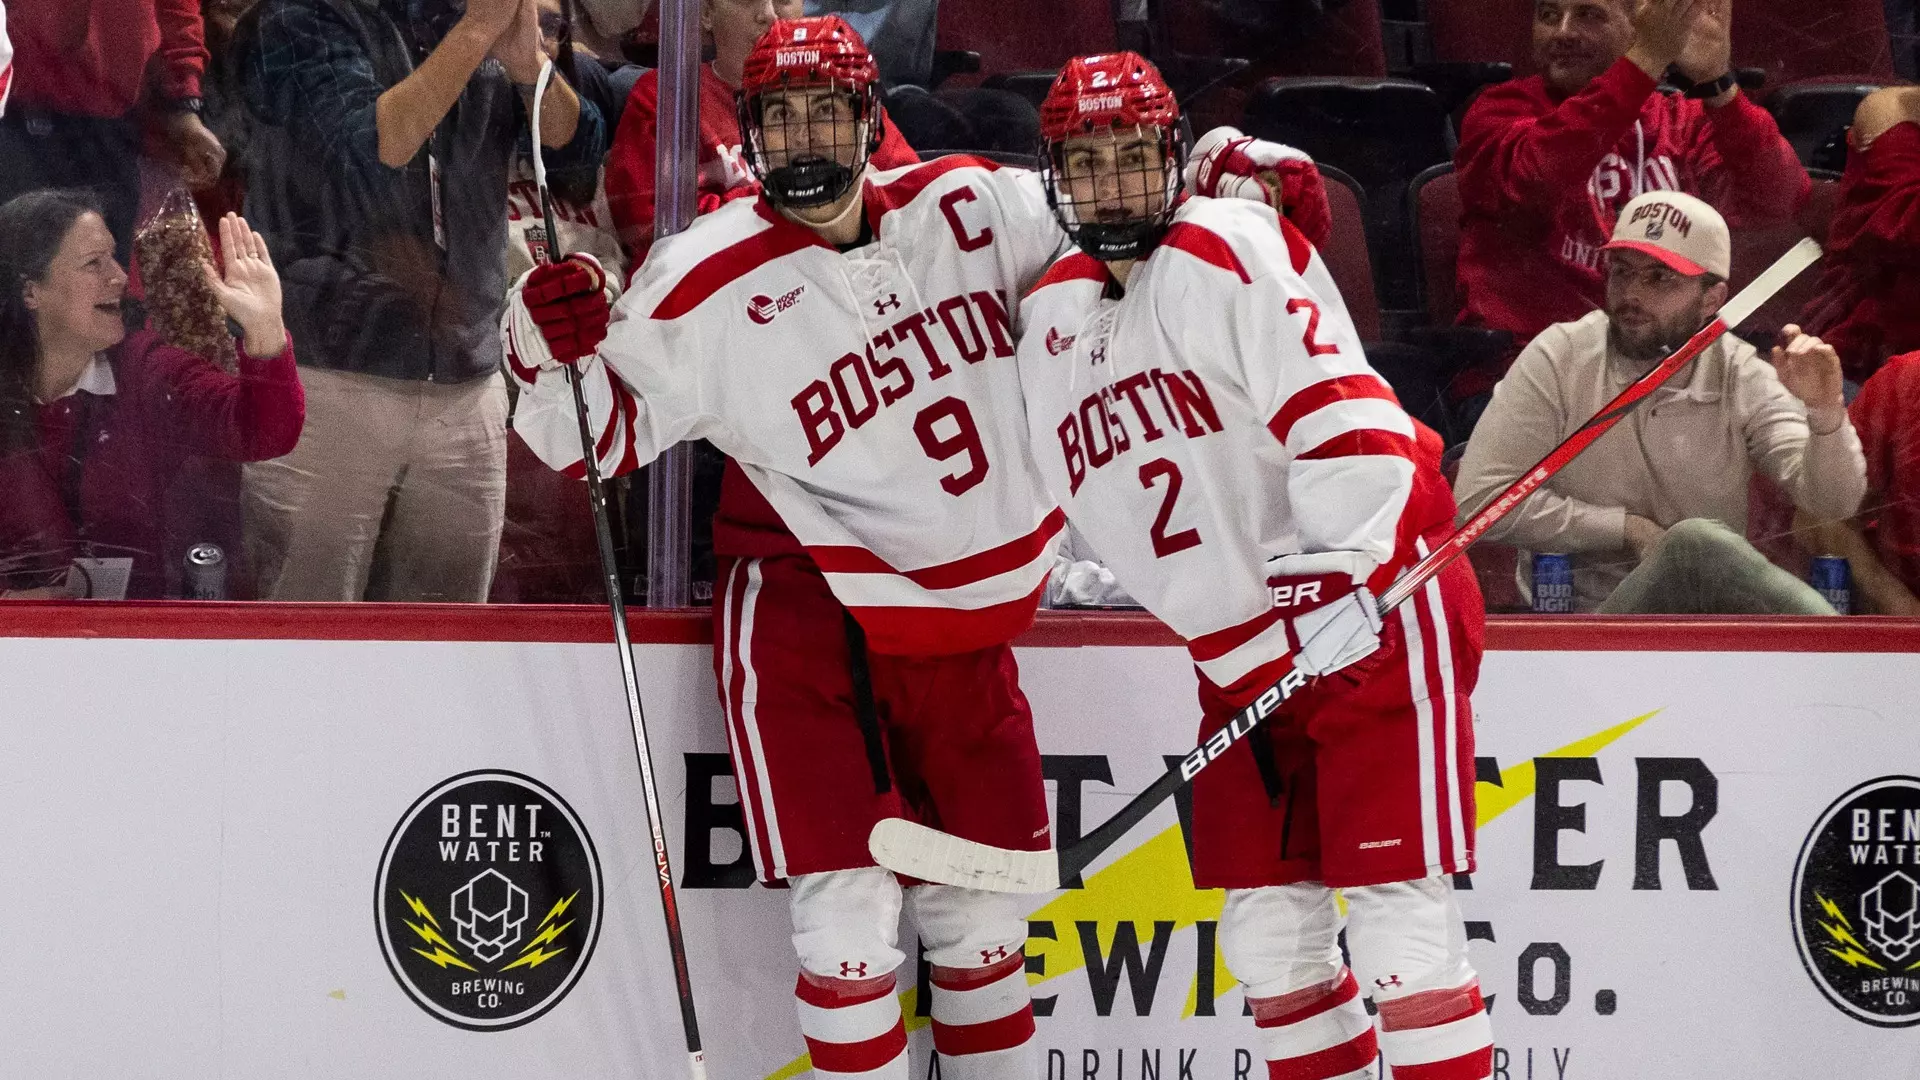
[1793,776,1920,1028]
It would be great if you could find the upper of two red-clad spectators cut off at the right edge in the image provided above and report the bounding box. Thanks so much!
[1805,86,1920,380]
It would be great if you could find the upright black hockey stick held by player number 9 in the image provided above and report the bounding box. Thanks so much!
[532,60,707,1080]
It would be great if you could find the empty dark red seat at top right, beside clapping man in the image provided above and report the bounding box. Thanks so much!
[1734,0,1893,86]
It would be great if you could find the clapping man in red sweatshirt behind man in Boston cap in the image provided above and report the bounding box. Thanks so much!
[1452,0,1812,400]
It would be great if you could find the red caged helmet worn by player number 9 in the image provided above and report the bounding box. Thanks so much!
[735,15,881,208]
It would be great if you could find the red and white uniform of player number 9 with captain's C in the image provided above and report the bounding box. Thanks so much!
[509,158,1064,1080]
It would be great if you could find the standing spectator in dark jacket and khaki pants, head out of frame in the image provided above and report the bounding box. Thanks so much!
[240,0,605,601]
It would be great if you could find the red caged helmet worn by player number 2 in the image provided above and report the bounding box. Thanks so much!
[1041,52,1187,261]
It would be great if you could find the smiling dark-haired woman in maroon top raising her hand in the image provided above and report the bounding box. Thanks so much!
[0,190,303,598]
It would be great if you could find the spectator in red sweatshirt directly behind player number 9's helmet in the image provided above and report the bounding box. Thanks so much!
[607,0,920,265]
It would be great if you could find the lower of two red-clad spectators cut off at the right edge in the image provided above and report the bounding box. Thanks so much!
[1797,352,1920,619]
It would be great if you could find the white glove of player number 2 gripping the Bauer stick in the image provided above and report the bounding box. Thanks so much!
[1267,552,1380,675]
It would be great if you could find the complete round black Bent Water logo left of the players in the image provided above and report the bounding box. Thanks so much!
[374,769,601,1032]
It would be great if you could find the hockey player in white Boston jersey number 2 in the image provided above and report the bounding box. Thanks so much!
[1018,54,1492,1080]
